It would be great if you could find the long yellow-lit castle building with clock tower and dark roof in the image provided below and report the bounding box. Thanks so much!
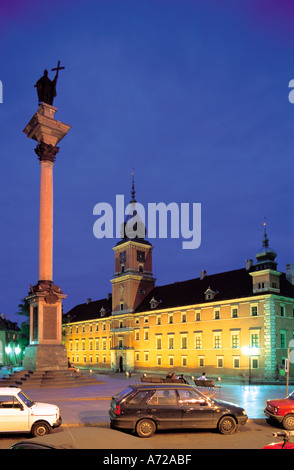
[63,188,294,381]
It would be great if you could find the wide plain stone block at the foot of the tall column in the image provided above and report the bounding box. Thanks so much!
[23,344,68,370]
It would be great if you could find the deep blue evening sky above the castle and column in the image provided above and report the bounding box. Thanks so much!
[0,0,294,321]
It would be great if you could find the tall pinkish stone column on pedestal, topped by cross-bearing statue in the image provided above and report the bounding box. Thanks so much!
[23,65,71,370]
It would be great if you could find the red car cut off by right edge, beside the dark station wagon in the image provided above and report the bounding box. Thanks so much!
[264,392,294,431]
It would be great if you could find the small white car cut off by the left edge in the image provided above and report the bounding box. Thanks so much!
[0,387,62,436]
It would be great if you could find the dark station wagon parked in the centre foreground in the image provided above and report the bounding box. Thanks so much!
[109,383,248,437]
